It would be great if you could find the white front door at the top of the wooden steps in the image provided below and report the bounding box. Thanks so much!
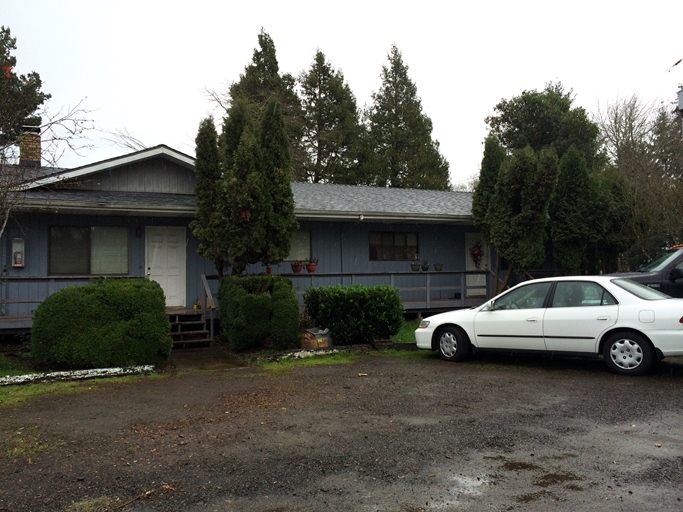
[145,226,185,306]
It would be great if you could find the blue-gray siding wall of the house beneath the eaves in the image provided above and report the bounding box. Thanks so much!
[0,214,475,315]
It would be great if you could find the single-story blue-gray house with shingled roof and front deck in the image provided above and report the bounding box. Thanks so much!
[0,135,490,327]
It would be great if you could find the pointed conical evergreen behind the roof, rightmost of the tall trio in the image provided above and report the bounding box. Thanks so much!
[362,45,450,190]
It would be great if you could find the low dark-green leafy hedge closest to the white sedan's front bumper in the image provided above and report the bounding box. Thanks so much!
[304,285,403,345]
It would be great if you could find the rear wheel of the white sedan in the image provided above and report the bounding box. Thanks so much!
[602,332,655,375]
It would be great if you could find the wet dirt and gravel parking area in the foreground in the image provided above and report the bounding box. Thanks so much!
[0,344,683,512]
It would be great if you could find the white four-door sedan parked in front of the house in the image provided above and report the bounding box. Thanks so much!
[415,276,683,375]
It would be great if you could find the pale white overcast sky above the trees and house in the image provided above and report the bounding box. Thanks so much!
[5,0,683,188]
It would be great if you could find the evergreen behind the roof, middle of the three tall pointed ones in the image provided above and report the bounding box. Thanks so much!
[299,50,360,183]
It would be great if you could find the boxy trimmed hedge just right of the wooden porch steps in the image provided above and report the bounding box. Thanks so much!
[218,275,300,352]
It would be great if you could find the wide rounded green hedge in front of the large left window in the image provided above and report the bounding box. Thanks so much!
[31,279,172,370]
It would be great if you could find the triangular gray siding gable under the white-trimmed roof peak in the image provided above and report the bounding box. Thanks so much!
[64,158,195,194]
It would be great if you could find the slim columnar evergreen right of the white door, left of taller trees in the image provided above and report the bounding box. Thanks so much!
[190,117,227,278]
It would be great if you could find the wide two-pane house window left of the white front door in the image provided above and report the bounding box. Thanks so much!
[48,226,128,275]
